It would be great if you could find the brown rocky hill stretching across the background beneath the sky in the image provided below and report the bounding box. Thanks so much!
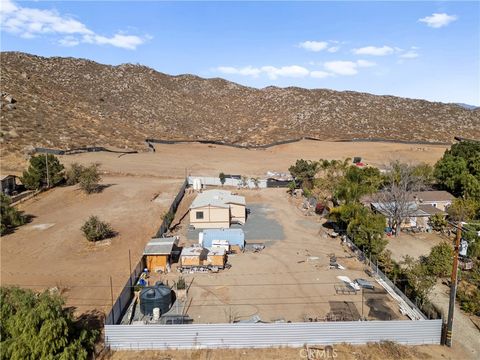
[0,52,480,154]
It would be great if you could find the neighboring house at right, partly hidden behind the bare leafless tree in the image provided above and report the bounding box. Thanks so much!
[362,191,455,229]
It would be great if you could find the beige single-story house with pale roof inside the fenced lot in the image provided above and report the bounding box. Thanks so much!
[190,190,246,229]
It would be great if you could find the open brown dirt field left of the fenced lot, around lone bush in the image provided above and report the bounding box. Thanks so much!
[0,177,181,312]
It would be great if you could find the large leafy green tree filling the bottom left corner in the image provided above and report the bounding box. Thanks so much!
[0,287,98,360]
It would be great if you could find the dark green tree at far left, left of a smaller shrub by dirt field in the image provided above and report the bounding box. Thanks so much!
[21,154,64,190]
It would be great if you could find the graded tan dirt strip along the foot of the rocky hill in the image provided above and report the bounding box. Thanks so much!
[2,140,447,177]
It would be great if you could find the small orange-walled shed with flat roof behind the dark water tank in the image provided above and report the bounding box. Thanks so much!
[143,236,179,272]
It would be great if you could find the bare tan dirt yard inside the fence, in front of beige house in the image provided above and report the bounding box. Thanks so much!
[159,189,404,323]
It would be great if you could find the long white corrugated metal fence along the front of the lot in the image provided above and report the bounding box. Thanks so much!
[105,320,442,350]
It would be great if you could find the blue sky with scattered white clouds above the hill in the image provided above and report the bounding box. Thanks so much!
[0,0,480,106]
